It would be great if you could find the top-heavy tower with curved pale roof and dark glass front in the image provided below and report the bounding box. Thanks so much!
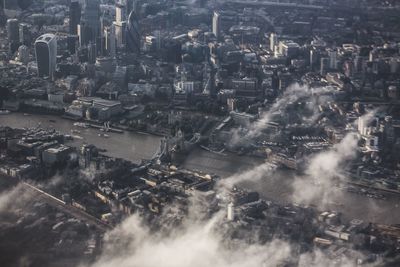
[35,34,57,79]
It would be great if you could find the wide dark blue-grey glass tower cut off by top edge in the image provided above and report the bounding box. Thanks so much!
[78,0,100,45]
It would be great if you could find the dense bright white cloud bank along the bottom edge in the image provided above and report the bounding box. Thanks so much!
[86,211,291,267]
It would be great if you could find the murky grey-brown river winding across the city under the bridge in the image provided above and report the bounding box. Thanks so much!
[0,113,400,224]
